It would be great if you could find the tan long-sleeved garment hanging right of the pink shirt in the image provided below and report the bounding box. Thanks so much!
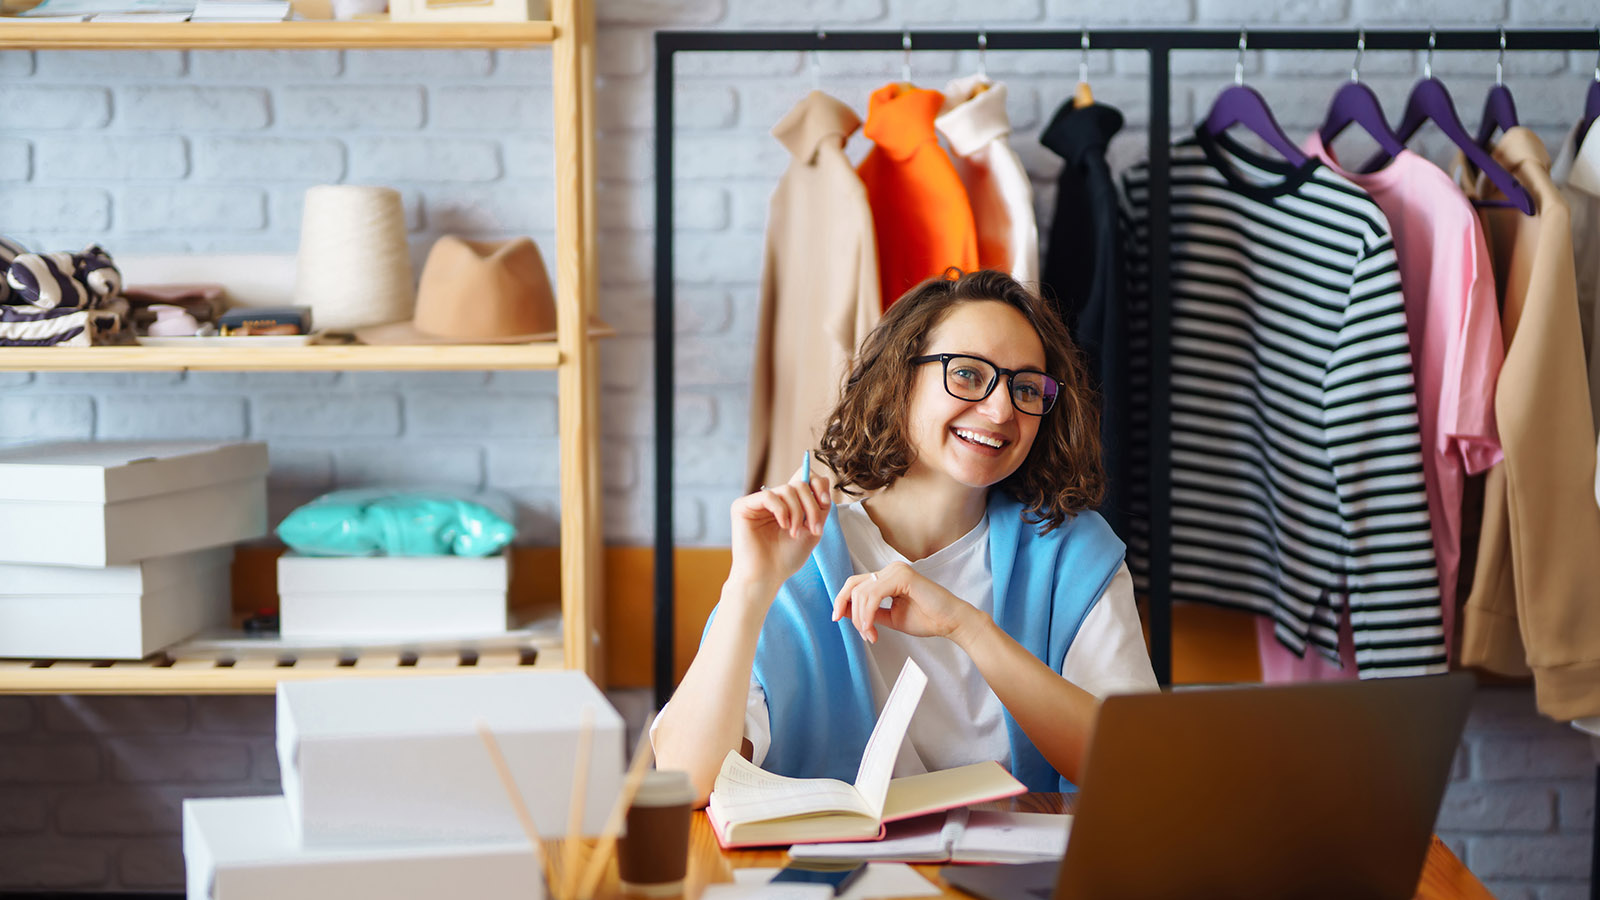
[1461,128,1600,719]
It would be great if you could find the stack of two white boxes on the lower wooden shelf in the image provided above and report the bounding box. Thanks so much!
[0,440,267,660]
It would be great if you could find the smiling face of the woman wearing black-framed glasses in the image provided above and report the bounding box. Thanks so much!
[907,299,1050,487]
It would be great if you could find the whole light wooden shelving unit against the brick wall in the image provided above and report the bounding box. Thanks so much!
[0,0,614,693]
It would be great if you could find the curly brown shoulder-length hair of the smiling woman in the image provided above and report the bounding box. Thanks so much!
[818,267,1106,533]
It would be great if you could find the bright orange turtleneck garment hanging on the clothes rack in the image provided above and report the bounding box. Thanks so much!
[856,83,978,309]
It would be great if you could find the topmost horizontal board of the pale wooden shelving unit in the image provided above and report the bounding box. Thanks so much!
[0,16,557,50]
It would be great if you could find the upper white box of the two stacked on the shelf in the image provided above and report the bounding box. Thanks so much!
[0,442,267,565]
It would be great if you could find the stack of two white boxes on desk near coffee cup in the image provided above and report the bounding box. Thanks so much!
[184,671,622,900]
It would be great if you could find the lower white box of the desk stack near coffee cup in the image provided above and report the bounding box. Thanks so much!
[184,796,544,900]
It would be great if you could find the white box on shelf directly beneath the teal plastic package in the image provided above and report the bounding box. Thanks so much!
[278,554,510,641]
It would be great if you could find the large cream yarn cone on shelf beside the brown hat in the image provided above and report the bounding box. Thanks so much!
[294,184,416,331]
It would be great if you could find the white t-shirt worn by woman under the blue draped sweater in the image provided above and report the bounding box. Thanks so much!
[744,503,1158,777]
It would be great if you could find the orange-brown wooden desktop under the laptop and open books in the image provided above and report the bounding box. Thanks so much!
[569,794,1494,900]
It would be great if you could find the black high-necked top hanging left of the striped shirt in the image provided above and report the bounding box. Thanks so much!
[1038,101,1131,541]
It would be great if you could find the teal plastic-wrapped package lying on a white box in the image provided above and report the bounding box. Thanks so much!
[277,488,517,556]
